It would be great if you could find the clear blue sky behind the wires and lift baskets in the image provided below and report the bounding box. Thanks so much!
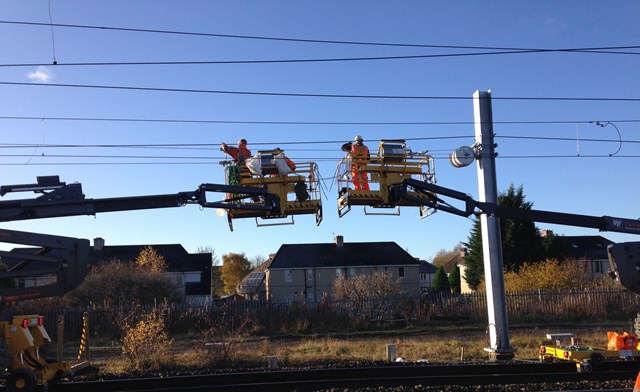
[0,0,640,259]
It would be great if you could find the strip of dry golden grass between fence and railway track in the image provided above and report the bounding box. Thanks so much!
[92,329,622,374]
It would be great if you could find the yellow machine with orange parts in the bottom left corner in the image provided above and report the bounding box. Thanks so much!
[0,315,71,392]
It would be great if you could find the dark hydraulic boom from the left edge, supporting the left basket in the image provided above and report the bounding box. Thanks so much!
[0,176,280,302]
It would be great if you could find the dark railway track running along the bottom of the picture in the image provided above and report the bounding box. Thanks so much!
[7,362,640,392]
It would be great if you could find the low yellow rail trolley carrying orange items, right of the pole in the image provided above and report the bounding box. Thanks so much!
[538,333,640,373]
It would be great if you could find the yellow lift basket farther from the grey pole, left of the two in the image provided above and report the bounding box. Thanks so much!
[225,149,322,230]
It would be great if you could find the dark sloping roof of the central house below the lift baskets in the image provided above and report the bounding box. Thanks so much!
[269,242,420,269]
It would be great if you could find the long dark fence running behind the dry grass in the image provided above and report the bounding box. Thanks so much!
[5,289,640,340]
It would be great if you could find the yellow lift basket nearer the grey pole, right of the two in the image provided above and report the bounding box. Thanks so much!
[336,140,436,218]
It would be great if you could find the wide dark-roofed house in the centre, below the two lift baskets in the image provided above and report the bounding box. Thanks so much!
[240,236,420,303]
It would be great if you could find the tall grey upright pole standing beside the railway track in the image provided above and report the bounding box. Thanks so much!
[473,91,515,360]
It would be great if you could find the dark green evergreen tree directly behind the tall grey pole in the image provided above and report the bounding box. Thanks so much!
[464,184,545,290]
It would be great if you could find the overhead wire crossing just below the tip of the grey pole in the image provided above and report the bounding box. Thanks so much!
[0,81,640,102]
